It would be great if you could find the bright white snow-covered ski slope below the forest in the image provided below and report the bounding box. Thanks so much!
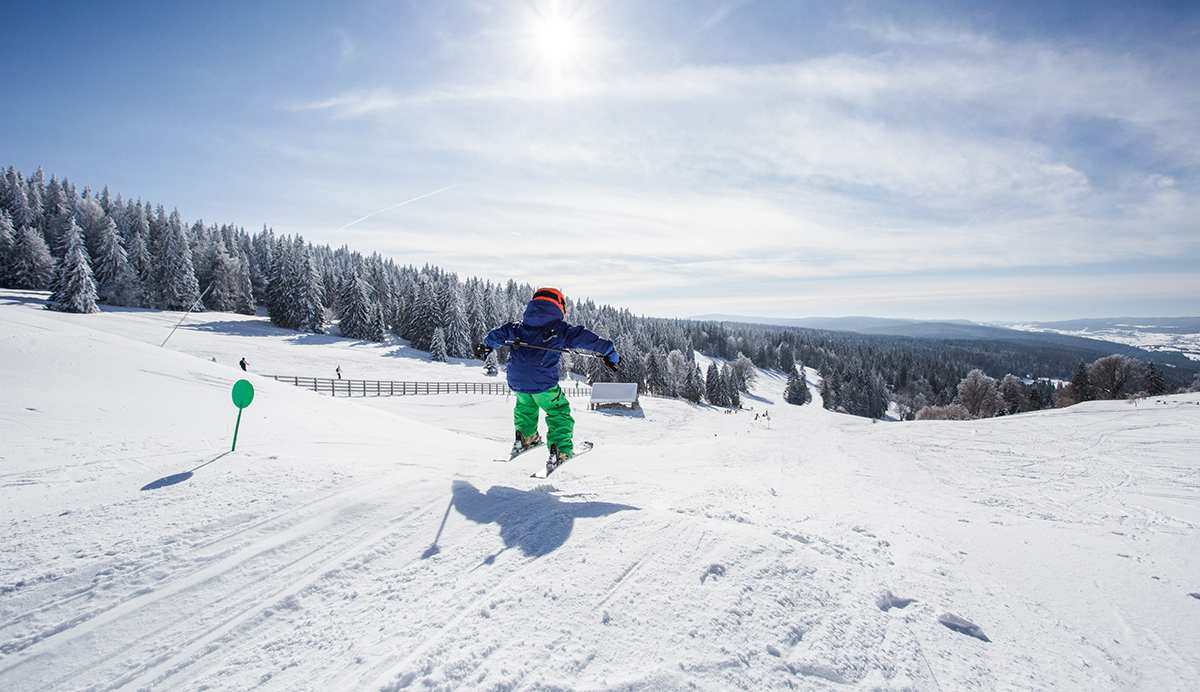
[0,291,1200,692]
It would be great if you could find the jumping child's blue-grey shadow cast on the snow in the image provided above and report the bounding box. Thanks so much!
[444,481,638,558]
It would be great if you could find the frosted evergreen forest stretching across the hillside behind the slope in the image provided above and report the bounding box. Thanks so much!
[0,167,1190,419]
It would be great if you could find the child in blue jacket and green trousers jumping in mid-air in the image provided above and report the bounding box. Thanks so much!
[475,288,620,470]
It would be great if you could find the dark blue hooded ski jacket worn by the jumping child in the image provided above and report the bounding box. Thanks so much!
[484,300,612,395]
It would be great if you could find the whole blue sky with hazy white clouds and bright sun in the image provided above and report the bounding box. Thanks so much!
[0,0,1200,320]
